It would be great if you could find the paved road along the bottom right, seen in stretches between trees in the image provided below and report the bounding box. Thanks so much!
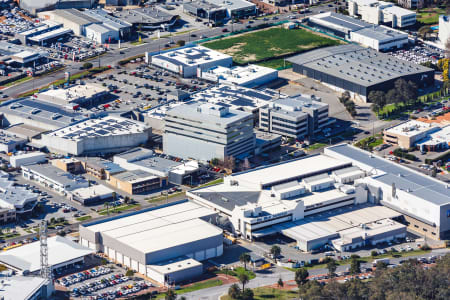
[183,249,450,300]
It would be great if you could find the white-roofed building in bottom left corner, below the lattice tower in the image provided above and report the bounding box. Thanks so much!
[0,276,54,300]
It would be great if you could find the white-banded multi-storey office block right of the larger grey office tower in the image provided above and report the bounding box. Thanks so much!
[259,96,330,140]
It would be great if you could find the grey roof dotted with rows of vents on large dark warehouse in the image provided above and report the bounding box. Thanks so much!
[287,44,433,86]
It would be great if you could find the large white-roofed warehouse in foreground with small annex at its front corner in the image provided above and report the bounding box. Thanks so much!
[80,200,223,285]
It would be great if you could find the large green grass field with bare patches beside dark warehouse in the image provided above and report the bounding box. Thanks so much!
[203,27,340,64]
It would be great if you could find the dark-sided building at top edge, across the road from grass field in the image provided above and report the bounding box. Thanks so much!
[183,0,227,23]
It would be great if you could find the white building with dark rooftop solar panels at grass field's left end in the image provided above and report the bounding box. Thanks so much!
[150,46,233,77]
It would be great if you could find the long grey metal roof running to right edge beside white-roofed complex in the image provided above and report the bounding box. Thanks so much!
[327,144,450,205]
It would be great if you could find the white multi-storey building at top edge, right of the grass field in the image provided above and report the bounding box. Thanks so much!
[347,0,416,28]
